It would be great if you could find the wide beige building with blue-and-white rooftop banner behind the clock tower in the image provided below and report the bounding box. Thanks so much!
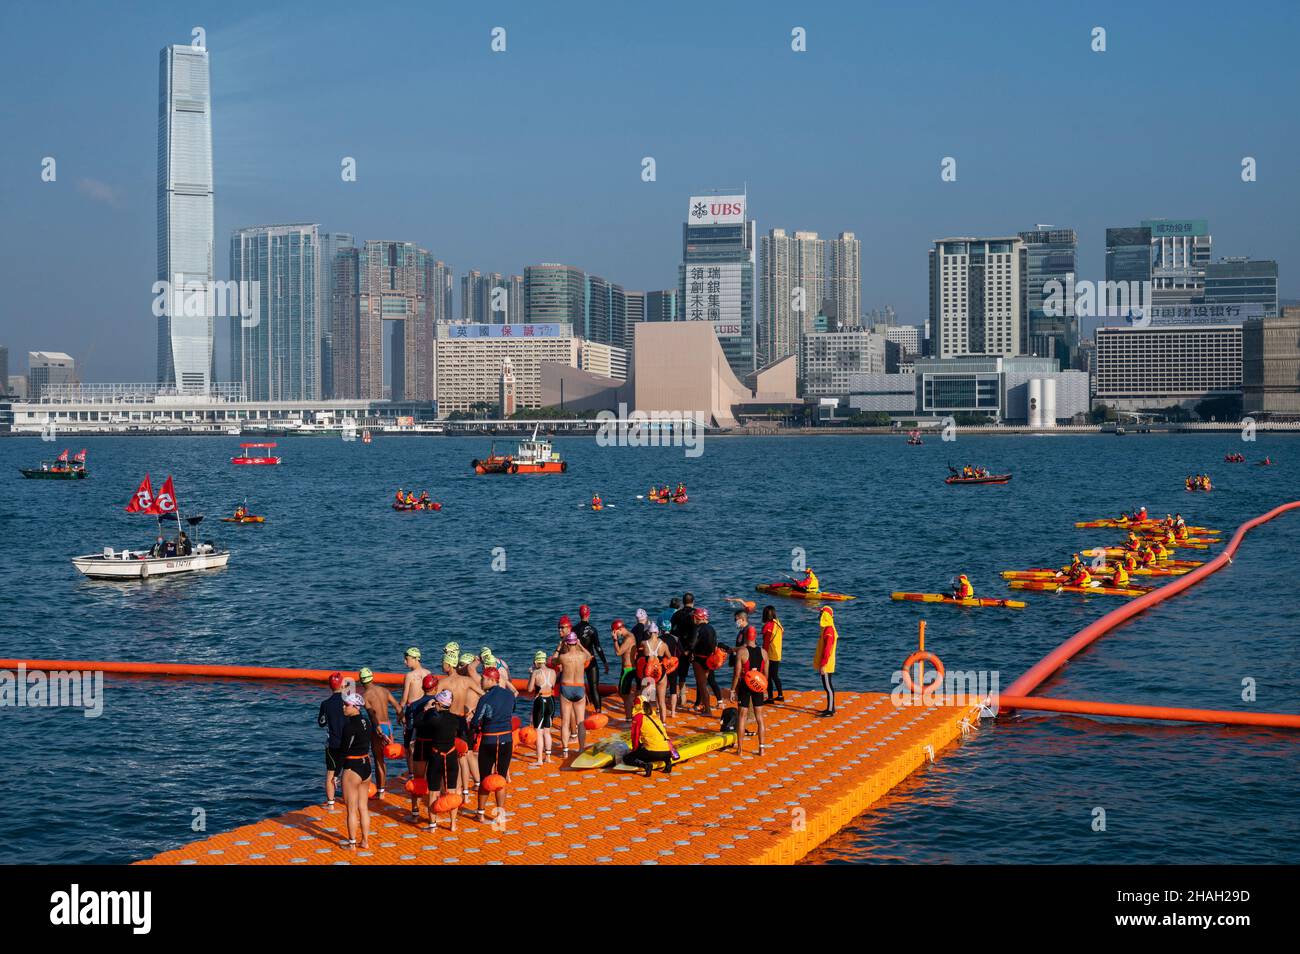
[434,322,580,417]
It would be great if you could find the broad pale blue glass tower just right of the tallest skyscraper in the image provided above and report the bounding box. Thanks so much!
[230,225,321,400]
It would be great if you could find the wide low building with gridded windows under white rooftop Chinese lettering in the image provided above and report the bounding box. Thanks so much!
[1095,324,1242,411]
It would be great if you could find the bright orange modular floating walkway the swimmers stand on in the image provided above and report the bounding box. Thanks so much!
[140,693,978,864]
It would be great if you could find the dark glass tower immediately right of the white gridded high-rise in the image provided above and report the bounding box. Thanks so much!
[1021,225,1079,368]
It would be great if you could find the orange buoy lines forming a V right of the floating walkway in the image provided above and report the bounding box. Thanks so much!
[998,500,1300,728]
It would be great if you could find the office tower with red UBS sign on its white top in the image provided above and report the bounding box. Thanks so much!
[677,195,758,378]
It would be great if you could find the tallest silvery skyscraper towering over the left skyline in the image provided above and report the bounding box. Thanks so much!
[157,44,216,394]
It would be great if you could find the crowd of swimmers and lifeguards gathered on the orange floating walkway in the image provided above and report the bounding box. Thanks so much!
[317,593,839,849]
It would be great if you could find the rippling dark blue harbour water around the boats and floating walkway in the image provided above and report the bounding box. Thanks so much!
[0,434,1300,864]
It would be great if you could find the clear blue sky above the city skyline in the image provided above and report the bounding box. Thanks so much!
[0,0,1300,381]
